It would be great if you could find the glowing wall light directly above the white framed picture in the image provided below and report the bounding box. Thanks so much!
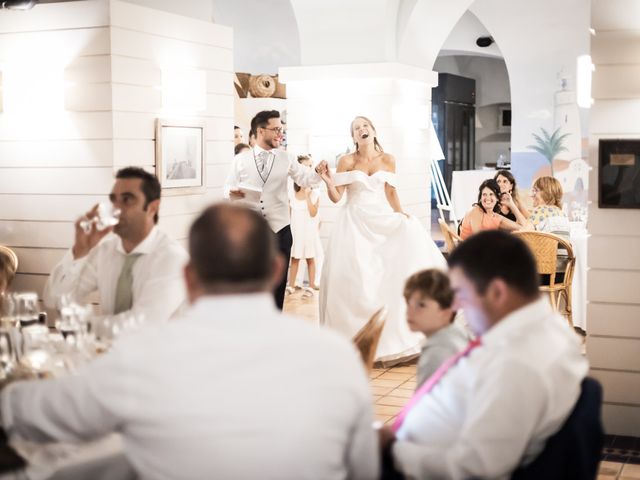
[162,68,207,113]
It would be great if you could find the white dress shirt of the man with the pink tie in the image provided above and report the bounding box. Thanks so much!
[393,298,588,479]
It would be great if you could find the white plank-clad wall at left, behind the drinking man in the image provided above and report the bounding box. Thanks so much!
[0,0,233,292]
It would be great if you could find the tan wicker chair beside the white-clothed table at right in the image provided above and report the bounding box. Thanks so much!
[513,232,576,327]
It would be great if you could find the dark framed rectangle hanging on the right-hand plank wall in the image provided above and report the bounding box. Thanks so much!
[598,139,640,208]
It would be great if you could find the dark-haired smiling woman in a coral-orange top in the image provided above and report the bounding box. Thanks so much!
[460,178,522,240]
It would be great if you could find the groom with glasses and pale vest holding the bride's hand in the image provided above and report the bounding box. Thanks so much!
[225,110,327,310]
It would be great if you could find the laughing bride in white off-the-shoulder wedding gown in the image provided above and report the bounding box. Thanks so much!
[320,117,446,365]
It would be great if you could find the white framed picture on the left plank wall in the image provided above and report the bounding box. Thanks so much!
[156,118,206,195]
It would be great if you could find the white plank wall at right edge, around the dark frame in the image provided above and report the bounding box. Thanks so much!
[587,0,640,436]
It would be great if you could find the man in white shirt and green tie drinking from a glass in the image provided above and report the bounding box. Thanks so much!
[44,167,187,322]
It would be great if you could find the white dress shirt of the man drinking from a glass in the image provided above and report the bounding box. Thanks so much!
[43,227,188,322]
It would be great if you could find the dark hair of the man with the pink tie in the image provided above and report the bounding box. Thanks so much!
[449,230,539,297]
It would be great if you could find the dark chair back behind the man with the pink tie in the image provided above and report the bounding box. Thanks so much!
[511,377,604,480]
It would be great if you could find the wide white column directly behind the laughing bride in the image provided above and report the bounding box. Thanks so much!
[280,63,438,246]
